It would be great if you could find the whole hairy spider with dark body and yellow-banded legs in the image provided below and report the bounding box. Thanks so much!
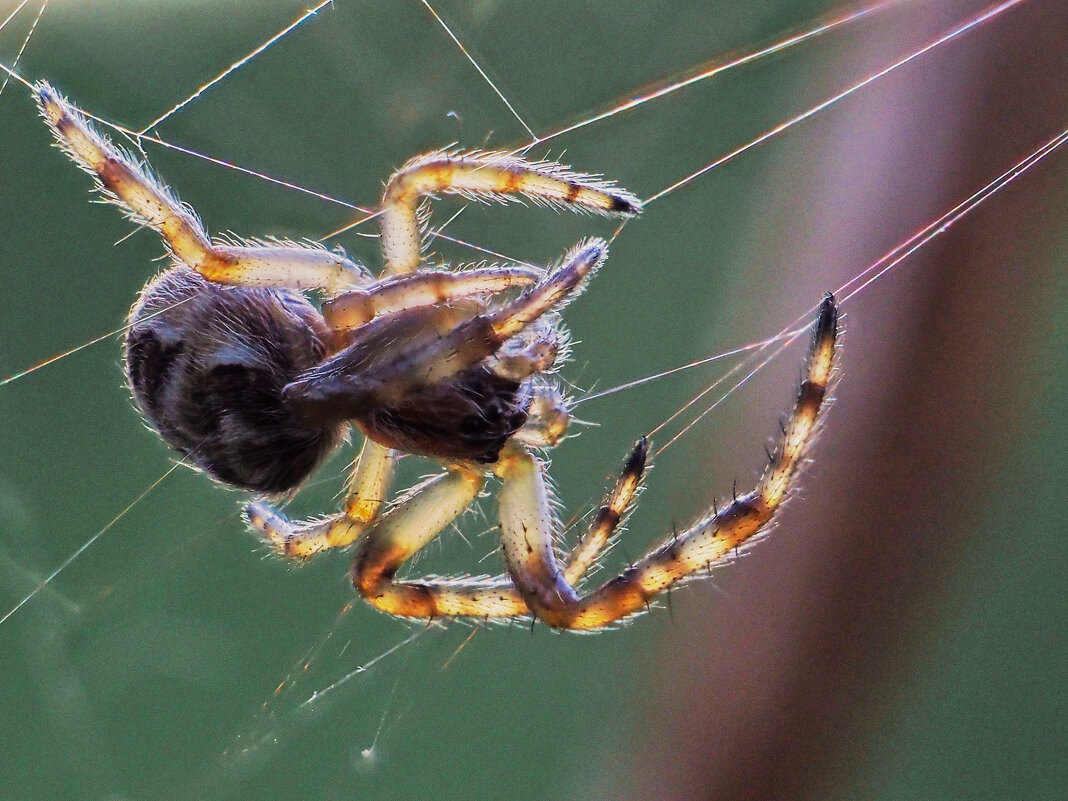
[35,83,837,630]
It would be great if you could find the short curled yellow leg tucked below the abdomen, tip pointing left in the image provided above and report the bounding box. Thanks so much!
[245,439,396,559]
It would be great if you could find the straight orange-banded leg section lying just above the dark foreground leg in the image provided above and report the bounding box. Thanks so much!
[323,267,543,330]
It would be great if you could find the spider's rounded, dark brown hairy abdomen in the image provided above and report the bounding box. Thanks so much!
[125,267,343,492]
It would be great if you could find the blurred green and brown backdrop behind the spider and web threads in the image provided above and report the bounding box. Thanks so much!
[0,0,1068,801]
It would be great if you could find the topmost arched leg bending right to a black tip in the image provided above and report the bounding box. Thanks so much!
[380,151,642,273]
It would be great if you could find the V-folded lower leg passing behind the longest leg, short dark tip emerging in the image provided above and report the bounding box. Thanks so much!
[350,440,646,621]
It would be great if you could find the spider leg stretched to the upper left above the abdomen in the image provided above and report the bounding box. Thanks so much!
[34,82,370,292]
